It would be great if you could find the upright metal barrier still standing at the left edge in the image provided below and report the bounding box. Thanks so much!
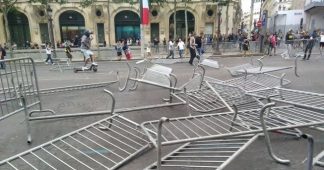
[0,58,42,121]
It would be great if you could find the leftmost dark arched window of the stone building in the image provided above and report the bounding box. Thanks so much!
[8,10,30,47]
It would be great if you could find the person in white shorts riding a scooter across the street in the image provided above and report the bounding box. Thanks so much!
[81,30,97,70]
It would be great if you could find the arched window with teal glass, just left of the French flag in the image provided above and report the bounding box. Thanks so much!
[115,10,140,42]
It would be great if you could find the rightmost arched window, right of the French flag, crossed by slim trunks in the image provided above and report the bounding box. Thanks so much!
[169,10,195,40]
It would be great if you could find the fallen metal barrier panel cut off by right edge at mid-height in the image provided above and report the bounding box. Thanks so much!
[247,87,324,111]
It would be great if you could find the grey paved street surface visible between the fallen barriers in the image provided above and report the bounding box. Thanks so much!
[0,52,324,170]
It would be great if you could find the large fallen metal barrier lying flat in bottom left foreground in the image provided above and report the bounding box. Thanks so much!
[0,115,150,170]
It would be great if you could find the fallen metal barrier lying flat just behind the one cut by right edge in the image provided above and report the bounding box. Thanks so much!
[224,73,291,91]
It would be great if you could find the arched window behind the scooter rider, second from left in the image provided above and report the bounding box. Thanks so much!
[59,11,85,46]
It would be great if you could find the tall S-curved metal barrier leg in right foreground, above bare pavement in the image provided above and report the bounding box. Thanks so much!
[260,103,290,164]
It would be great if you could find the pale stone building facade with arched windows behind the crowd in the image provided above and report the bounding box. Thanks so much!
[0,0,241,47]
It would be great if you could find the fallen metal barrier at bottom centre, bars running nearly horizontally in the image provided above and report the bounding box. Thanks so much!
[145,135,258,170]
